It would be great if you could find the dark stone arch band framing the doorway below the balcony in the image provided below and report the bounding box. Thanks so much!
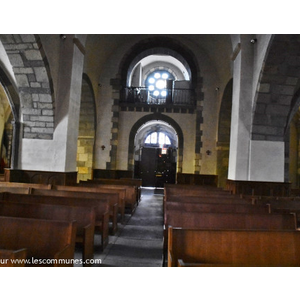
[128,113,183,172]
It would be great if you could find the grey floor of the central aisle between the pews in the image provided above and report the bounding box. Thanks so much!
[76,188,163,267]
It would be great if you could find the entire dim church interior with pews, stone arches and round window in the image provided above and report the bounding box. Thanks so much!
[0,11,300,296]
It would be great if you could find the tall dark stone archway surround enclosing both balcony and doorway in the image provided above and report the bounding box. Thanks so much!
[107,36,204,174]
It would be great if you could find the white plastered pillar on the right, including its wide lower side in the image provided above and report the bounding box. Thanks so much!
[228,36,285,182]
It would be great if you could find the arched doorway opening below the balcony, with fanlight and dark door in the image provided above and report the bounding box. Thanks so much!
[134,120,178,188]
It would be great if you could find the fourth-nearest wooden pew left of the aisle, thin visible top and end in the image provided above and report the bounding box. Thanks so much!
[0,193,109,250]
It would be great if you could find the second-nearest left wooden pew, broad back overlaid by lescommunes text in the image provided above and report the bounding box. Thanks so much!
[0,216,76,267]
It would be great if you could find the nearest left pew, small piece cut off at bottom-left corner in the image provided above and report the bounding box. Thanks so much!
[0,249,27,267]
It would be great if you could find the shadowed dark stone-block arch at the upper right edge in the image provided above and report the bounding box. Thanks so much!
[251,35,300,141]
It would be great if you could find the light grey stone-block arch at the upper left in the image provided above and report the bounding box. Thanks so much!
[0,34,54,139]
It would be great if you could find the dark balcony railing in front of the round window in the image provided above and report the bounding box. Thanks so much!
[121,87,195,106]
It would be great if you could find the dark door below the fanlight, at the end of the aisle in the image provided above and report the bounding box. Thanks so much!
[140,148,176,187]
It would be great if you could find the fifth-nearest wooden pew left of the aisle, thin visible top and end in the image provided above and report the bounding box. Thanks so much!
[30,187,119,234]
